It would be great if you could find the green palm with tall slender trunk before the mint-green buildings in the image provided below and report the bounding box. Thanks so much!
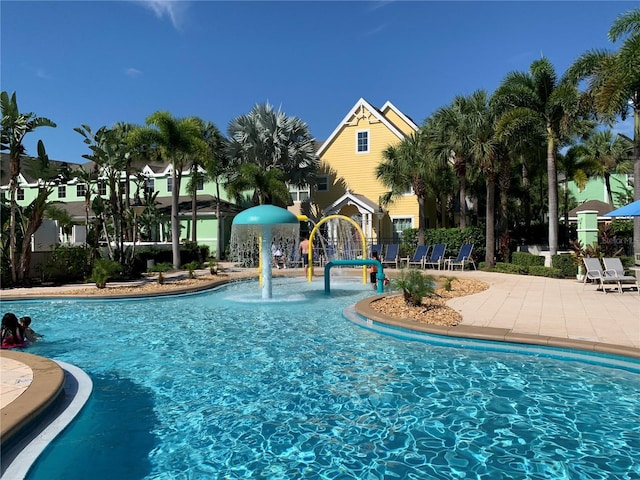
[129,111,206,268]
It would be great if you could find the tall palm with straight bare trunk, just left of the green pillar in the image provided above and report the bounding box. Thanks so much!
[494,58,580,255]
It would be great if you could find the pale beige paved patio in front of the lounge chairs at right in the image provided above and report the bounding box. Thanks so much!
[448,271,640,349]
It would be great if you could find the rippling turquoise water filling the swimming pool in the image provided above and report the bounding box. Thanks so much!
[4,278,640,480]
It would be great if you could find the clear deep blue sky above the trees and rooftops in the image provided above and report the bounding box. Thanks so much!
[0,0,639,163]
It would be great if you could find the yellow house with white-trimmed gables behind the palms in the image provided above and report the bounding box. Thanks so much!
[311,98,418,243]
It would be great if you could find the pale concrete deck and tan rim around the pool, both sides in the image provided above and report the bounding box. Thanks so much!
[0,268,640,464]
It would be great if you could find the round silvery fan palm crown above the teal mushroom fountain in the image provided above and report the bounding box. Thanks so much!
[227,103,318,205]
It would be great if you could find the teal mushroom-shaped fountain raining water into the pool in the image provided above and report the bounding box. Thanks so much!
[231,205,300,299]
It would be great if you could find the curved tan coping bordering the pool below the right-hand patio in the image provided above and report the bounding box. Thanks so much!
[354,295,640,359]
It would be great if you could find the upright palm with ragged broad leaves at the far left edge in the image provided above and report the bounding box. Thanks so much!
[0,91,56,283]
